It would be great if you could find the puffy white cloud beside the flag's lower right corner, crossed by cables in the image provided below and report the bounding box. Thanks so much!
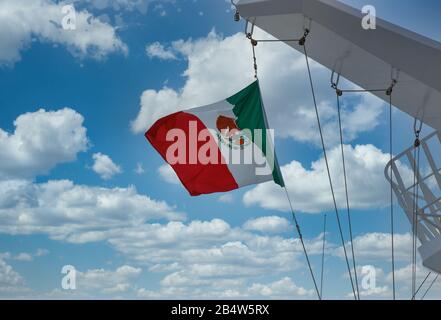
[243,145,389,213]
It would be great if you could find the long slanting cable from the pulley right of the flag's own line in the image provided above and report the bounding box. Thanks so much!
[299,29,357,300]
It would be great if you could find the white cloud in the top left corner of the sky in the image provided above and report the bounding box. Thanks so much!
[0,0,128,65]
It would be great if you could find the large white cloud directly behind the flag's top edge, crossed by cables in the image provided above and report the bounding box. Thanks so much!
[131,30,382,145]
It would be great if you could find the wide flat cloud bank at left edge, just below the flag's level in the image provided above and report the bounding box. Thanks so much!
[0,180,184,243]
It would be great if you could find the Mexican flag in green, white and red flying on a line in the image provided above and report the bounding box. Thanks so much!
[145,81,284,196]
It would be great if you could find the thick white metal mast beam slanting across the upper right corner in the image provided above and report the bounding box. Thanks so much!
[237,0,441,130]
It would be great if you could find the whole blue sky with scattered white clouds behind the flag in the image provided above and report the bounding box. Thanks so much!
[0,0,441,299]
